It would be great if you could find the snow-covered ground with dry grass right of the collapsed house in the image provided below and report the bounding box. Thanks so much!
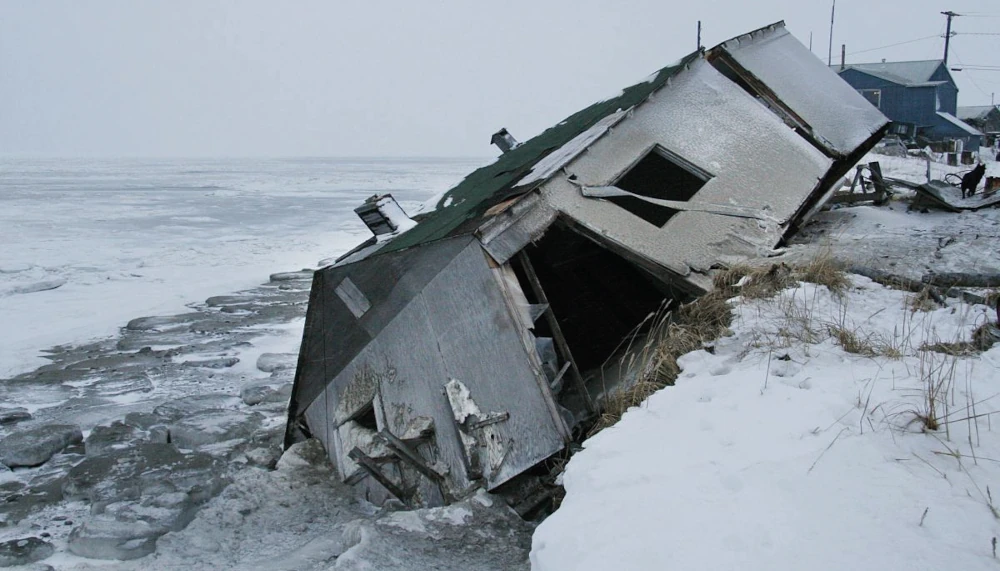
[531,150,1000,571]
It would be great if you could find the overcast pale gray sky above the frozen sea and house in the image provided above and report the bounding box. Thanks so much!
[0,0,1000,156]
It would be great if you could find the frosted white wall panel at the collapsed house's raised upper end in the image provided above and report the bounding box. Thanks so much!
[725,27,889,155]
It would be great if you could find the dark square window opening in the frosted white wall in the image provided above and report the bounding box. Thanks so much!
[608,145,712,227]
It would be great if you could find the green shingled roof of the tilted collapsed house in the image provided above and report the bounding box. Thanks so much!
[376,52,701,255]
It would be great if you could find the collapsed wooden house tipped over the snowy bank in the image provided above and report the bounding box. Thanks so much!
[286,22,888,505]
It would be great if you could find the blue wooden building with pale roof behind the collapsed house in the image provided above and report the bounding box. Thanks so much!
[833,60,982,149]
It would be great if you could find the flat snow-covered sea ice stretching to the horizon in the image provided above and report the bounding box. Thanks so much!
[0,159,484,379]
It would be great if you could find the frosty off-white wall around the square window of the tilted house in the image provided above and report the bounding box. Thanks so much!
[542,60,832,286]
